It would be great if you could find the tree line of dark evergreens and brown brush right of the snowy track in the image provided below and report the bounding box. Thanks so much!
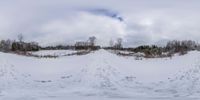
[105,40,200,58]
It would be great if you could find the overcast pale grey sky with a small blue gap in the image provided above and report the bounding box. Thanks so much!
[0,0,200,46]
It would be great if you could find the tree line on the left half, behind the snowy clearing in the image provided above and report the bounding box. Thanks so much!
[0,34,101,52]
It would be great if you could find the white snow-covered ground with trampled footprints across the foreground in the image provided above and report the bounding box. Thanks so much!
[0,50,200,100]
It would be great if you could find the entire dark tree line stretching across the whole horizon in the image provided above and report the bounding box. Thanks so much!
[0,34,200,57]
